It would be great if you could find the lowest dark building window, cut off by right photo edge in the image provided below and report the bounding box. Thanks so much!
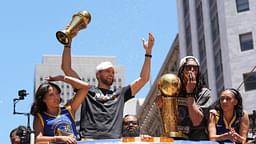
[243,72,256,91]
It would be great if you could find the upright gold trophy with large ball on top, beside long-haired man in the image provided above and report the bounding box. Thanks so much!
[158,73,183,138]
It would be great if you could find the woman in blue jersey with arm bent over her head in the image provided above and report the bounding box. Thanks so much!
[31,75,88,144]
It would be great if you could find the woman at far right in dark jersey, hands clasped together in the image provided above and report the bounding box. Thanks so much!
[208,88,249,144]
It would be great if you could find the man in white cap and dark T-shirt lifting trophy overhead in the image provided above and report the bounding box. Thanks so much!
[56,10,155,139]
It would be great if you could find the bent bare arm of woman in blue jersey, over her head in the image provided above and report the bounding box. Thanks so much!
[48,75,88,114]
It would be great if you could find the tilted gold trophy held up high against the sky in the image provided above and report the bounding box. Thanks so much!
[56,11,91,45]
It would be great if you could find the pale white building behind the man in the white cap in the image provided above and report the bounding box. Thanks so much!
[35,56,125,121]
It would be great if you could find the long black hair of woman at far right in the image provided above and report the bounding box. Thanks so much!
[212,88,243,118]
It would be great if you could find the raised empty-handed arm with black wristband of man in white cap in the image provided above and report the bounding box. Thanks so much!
[131,33,155,96]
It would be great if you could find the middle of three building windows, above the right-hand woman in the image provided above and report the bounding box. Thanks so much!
[239,32,253,51]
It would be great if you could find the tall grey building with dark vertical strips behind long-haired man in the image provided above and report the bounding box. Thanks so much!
[176,0,256,113]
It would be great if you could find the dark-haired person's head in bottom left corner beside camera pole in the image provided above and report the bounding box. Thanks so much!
[10,125,30,144]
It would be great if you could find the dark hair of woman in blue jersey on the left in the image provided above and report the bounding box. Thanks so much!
[30,82,61,115]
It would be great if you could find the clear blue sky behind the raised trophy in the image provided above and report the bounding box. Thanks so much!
[0,0,178,144]
